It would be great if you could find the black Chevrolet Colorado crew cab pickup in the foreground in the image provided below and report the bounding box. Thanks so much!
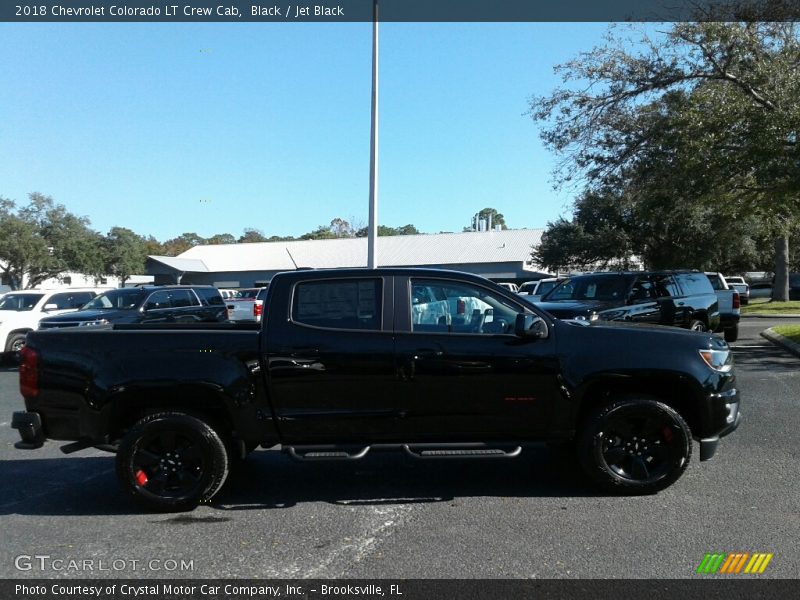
[12,269,740,511]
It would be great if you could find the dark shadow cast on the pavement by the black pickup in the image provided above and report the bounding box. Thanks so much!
[0,446,598,517]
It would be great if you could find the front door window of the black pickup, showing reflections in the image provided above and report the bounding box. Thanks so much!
[411,279,521,334]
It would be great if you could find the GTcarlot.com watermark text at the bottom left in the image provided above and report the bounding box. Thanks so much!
[14,554,194,573]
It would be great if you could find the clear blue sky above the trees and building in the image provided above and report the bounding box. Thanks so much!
[0,23,607,241]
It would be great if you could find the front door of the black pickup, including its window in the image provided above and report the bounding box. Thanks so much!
[395,276,560,441]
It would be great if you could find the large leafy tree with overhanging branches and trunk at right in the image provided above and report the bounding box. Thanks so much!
[531,17,800,299]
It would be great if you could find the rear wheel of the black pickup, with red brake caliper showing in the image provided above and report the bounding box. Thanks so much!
[116,412,229,512]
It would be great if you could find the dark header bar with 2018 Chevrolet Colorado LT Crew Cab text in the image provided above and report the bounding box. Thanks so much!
[0,0,800,23]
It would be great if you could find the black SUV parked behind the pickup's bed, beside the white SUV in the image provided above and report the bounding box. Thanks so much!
[39,285,228,329]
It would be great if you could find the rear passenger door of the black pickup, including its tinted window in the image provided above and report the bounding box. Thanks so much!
[262,273,398,443]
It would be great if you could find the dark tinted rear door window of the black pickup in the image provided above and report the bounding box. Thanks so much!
[292,279,381,330]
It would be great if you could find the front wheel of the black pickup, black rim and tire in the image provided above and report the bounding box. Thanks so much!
[579,397,692,495]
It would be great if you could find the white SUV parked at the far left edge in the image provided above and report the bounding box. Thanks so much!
[0,288,106,352]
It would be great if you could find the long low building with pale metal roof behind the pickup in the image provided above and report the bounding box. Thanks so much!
[147,229,544,288]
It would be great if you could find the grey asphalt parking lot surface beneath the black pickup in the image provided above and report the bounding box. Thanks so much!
[0,318,800,579]
